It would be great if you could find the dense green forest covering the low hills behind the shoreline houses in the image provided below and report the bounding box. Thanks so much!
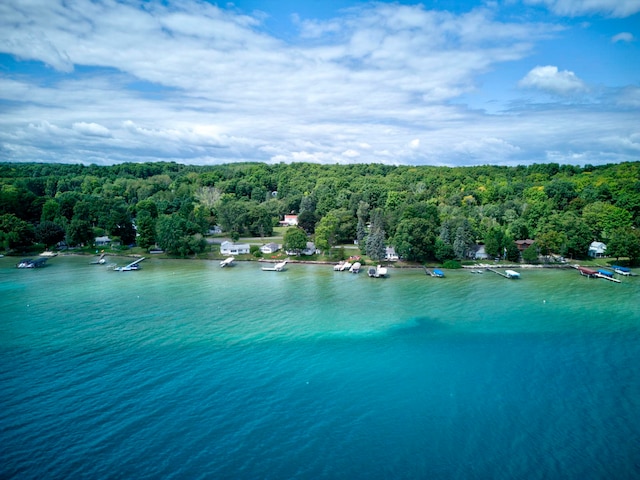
[0,162,640,263]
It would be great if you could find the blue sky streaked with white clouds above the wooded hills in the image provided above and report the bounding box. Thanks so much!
[0,0,640,166]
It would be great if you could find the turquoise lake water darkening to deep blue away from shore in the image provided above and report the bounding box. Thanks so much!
[0,257,640,479]
